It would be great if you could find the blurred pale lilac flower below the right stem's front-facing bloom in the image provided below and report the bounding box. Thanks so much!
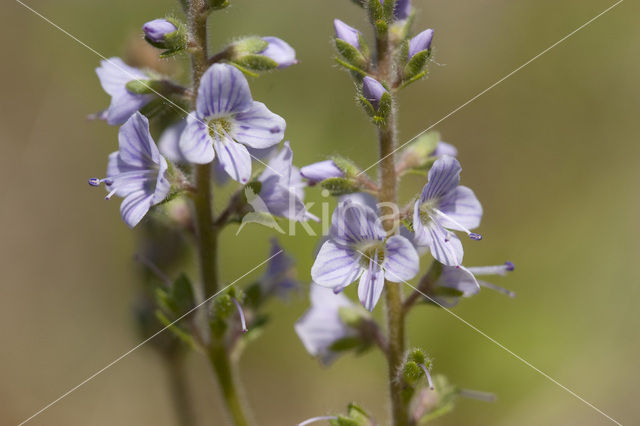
[294,284,357,365]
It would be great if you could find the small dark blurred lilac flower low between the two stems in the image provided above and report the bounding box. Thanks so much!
[260,238,300,299]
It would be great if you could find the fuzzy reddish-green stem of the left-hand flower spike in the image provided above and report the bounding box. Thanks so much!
[188,0,248,426]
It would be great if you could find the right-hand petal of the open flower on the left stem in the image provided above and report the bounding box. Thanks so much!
[229,102,287,149]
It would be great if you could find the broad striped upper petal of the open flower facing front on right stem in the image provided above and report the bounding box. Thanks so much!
[329,200,386,246]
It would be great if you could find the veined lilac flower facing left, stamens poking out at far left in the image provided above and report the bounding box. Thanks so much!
[89,112,171,228]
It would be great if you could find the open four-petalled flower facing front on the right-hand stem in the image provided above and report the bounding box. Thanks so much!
[311,200,420,311]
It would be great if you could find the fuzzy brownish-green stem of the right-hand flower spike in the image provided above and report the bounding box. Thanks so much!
[376,25,409,426]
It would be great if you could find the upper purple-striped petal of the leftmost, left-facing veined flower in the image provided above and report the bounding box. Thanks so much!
[118,112,161,168]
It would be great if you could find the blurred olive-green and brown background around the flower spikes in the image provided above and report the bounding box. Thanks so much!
[0,0,640,425]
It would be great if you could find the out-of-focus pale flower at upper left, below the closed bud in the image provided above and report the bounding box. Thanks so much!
[96,57,153,125]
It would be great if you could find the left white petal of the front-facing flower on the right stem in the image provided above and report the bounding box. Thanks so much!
[311,241,362,291]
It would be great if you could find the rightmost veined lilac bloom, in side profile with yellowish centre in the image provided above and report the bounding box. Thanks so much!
[413,155,482,266]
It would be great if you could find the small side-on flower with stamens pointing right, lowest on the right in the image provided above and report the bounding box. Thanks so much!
[433,262,515,307]
